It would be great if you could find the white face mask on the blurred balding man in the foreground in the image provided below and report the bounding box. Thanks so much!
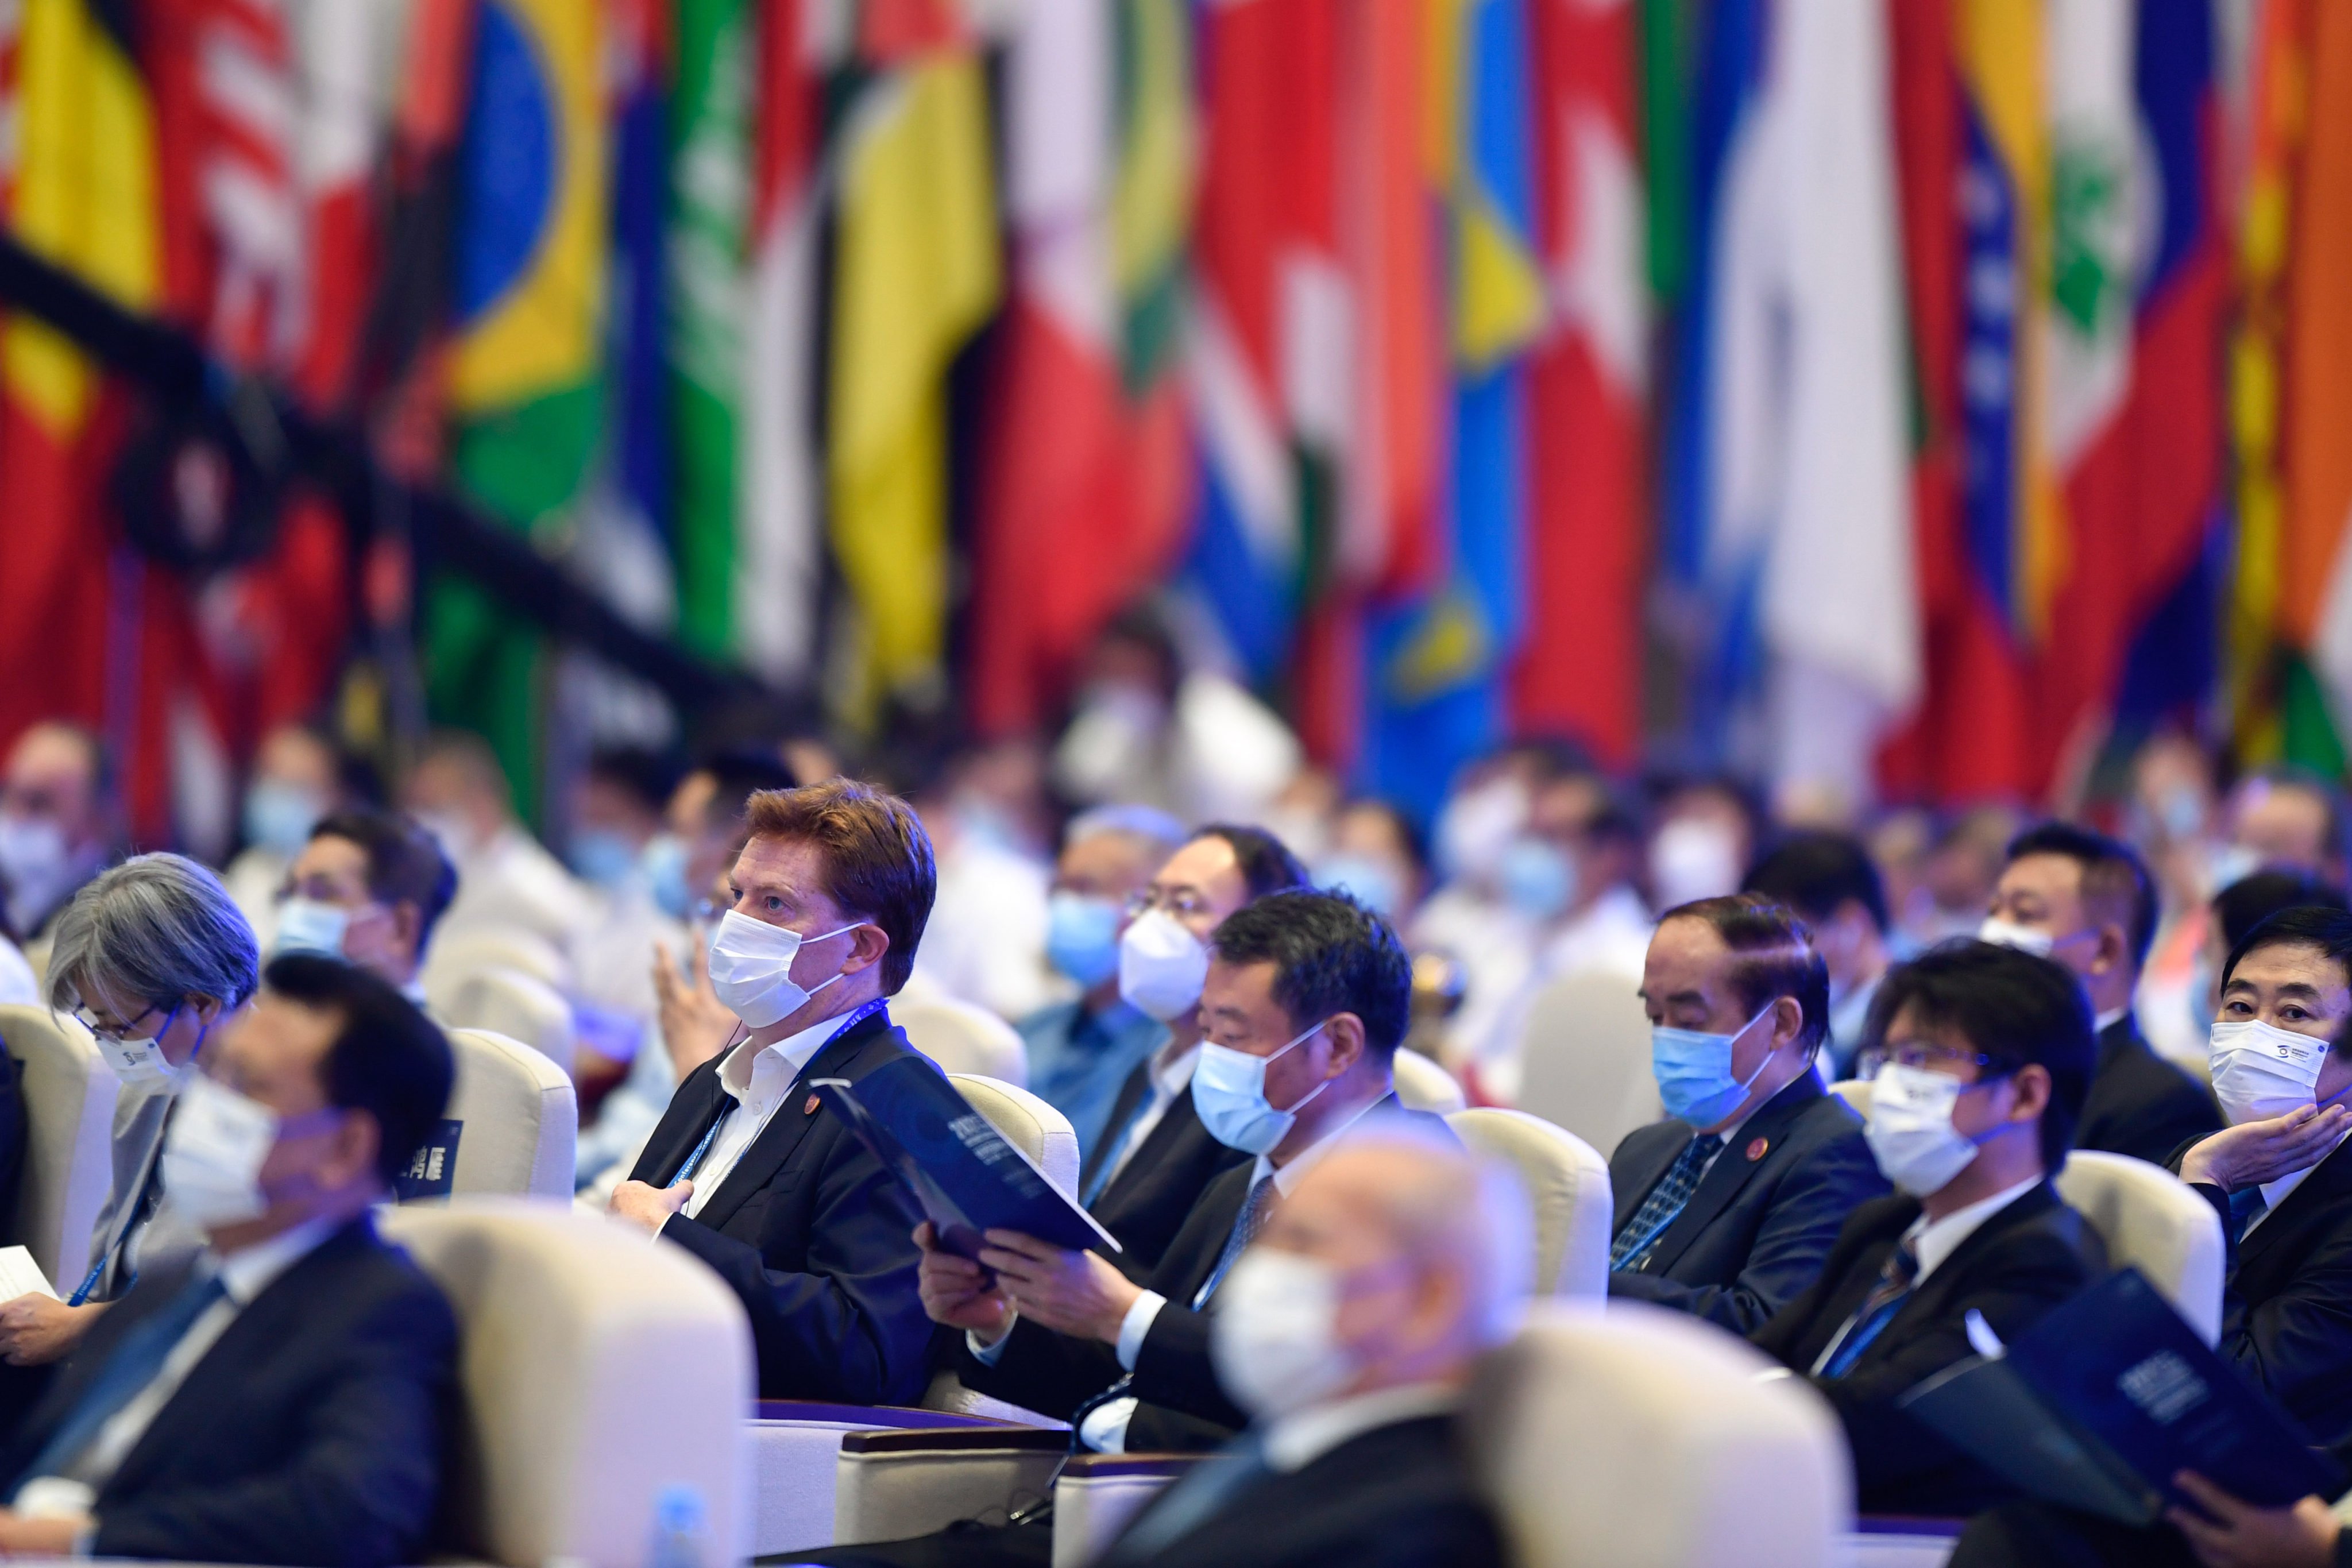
[1209,1246,1355,1420]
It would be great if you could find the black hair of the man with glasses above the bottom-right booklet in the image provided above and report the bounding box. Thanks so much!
[1863,936,2098,1175]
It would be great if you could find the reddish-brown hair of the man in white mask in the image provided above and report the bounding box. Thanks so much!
[743,778,939,997]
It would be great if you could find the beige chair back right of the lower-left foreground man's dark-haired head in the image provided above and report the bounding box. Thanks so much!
[426,1030,581,1204]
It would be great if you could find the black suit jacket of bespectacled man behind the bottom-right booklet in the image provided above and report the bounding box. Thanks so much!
[1752,1183,2107,1516]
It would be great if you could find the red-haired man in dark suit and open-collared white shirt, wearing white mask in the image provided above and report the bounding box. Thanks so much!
[612,781,939,1403]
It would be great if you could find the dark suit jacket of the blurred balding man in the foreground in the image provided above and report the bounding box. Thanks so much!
[1103,1415,1508,1568]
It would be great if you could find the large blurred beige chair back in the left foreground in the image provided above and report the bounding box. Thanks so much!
[383,1199,752,1568]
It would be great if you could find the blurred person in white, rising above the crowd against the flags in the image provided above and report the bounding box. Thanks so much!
[1051,607,1303,823]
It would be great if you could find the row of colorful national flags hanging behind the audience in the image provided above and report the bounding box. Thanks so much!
[14,0,2352,841]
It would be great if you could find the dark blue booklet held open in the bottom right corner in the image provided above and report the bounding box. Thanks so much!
[1896,1269,2345,1525]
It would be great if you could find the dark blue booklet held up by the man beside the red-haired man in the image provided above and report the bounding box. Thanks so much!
[809,1056,1119,1258]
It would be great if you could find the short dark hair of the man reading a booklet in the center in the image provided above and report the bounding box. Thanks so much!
[1209,889,1413,1058]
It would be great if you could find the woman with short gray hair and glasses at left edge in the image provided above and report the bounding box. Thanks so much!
[0,853,261,1366]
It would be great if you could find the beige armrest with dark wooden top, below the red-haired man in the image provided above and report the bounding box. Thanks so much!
[833,1413,1070,1547]
